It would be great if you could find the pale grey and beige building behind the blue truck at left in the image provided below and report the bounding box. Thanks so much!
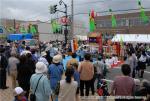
[1,19,64,41]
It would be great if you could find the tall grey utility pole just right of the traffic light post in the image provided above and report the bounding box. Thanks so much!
[70,0,74,39]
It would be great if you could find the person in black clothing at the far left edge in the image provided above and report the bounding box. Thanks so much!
[0,46,8,89]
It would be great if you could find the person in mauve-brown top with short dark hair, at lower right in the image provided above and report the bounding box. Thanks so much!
[111,64,135,97]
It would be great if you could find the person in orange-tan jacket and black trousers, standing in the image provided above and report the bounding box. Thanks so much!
[78,53,94,96]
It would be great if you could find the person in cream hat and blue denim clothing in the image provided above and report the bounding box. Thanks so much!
[48,55,63,91]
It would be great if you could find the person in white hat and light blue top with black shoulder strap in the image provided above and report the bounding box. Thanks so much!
[30,62,51,101]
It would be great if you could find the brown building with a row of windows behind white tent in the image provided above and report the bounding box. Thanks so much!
[95,11,150,34]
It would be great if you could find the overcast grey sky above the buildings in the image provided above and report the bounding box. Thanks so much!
[0,0,150,28]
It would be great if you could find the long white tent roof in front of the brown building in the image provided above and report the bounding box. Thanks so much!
[112,34,150,43]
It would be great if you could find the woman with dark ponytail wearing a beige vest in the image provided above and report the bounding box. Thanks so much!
[58,68,78,101]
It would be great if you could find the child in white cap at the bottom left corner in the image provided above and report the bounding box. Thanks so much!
[13,87,28,101]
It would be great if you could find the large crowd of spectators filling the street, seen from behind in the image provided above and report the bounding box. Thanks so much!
[0,42,150,101]
